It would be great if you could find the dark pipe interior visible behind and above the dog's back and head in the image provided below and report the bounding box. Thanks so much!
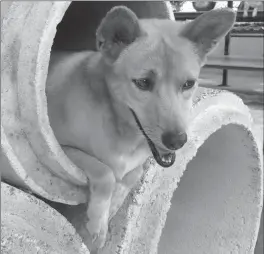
[52,1,171,50]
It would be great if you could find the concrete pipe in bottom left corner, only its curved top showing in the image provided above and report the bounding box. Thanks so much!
[1,183,89,254]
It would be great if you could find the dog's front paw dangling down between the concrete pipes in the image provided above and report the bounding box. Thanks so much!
[86,213,108,249]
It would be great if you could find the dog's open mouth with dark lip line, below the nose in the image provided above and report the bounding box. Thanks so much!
[130,108,176,168]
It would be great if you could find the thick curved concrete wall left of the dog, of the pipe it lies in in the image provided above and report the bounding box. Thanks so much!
[1,2,87,204]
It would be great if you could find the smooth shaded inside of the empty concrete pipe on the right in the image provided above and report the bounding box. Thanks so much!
[158,124,261,254]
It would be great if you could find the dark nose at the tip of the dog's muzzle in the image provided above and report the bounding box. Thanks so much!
[161,132,188,150]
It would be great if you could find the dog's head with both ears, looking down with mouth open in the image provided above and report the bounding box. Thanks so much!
[97,6,235,167]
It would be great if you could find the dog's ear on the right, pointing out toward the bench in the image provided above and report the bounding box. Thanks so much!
[180,8,236,61]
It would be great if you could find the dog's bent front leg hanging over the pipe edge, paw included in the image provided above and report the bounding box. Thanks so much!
[63,147,115,248]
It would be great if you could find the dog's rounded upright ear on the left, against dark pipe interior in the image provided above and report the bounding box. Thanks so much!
[96,6,141,62]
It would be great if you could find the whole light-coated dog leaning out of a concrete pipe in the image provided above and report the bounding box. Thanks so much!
[46,6,236,248]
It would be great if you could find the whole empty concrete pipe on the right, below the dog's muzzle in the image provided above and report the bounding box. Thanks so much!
[100,90,263,254]
